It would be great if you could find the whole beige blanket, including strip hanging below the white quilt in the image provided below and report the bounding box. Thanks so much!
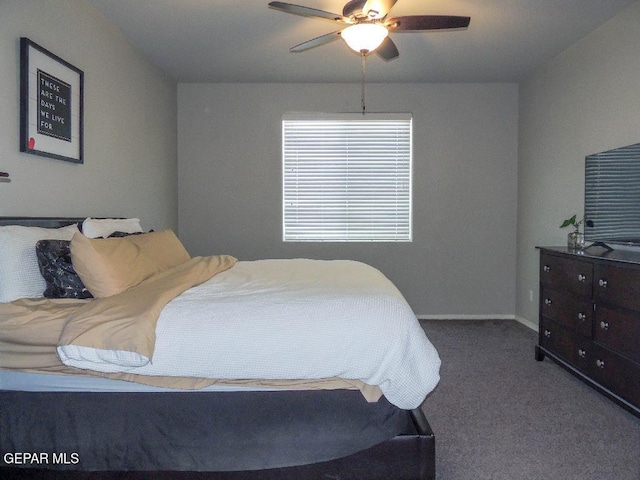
[0,255,382,401]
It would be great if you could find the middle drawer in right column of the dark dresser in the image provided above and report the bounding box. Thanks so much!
[593,304,640,363]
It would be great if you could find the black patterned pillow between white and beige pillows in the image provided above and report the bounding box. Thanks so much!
[36,240,93,298]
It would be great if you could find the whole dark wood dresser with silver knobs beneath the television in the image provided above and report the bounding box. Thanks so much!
[536,247,640,416]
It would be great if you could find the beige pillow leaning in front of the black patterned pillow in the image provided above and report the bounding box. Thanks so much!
[71,230,190,298]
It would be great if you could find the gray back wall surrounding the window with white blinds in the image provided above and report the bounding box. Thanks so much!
[178,84,518,318]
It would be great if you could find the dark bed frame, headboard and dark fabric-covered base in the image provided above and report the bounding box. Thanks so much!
[0,217,435,480]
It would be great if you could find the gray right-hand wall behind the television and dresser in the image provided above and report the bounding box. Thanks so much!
[516,2,640,324]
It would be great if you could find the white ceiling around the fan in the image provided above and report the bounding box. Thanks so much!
[89,0,637,83]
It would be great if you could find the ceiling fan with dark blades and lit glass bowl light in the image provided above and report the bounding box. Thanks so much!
[269,0,471,60]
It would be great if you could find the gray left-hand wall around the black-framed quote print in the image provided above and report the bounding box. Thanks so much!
[0,0,178,232]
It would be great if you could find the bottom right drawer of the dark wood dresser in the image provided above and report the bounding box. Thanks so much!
[591,344,640,407]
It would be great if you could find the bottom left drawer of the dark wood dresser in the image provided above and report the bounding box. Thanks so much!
[540,317,595,375]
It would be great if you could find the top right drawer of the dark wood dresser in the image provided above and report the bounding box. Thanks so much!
[593,264,640,315]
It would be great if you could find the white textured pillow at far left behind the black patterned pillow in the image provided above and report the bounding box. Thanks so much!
[0,224,78,302]
